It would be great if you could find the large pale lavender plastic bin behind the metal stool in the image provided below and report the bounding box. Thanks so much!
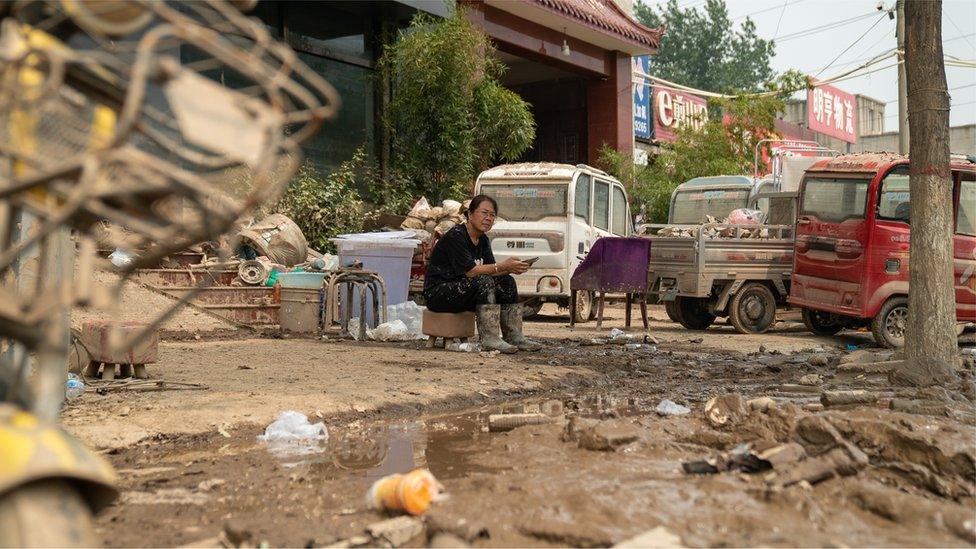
[332,231,420,326]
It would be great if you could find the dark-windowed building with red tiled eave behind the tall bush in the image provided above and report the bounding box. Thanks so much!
[214,0,663,181]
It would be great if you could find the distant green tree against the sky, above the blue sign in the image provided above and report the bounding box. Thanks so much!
[634,0,775,93]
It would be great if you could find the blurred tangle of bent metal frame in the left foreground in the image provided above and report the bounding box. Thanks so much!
[0,1,339,419]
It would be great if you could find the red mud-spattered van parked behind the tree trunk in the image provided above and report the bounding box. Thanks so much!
[790,153,976,348]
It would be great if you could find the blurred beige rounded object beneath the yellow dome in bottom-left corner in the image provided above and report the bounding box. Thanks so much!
[0,479,101,547]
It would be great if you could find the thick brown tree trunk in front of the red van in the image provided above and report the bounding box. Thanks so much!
[902,0,959,364]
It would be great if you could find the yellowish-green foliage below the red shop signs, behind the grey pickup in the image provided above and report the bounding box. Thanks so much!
[600,72,808,223]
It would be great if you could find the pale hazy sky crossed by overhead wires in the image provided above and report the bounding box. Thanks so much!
[643,0,976,131]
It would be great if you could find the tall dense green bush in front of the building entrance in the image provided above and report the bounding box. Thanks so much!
[380,7,535,202]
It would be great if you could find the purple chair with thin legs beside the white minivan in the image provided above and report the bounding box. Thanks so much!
[569,236,651,329]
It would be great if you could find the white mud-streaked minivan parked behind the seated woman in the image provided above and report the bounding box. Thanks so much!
[475,163,633,322]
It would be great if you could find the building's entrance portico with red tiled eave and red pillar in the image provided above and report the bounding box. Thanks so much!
[460,0,663,165]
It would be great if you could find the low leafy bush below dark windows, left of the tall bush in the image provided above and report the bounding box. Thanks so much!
[272,154,366,252]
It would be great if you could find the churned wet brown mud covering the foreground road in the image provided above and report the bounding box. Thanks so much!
[84,310,976,547]
